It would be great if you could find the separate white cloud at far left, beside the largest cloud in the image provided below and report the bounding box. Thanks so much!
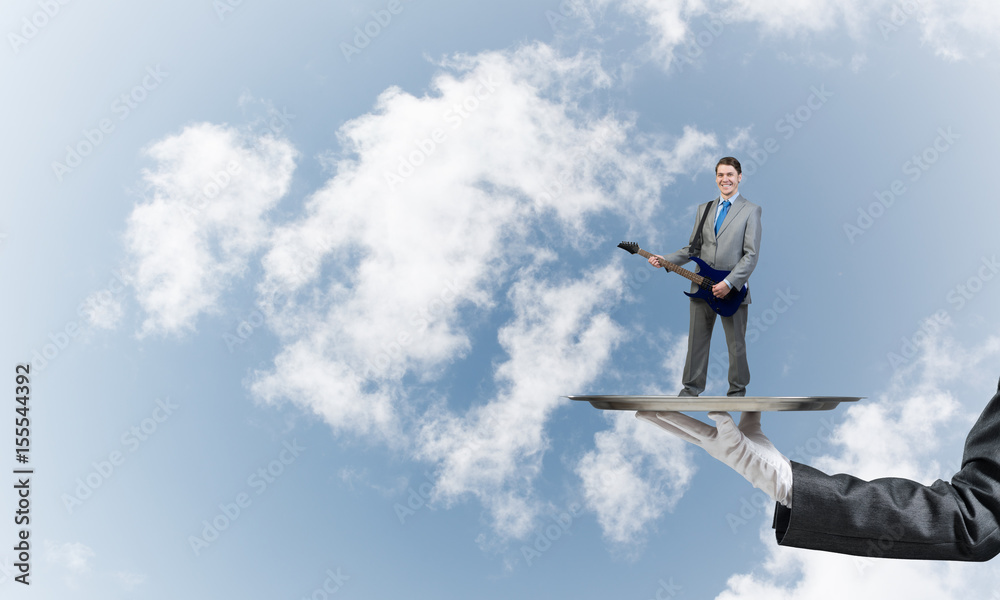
[126,123,295,335]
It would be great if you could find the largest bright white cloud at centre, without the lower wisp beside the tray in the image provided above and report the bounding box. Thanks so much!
[254,45,711,436]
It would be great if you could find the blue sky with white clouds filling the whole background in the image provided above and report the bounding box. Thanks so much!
[0,0,1000,599]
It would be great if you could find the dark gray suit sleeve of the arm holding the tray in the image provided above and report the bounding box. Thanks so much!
[774,386,1000,561]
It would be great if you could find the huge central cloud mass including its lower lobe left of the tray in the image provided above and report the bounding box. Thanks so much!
[241,44,716,537]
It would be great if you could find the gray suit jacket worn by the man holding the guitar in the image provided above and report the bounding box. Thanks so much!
[663,194,761,304]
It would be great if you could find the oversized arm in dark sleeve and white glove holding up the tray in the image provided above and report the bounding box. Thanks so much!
[636,383,1000,561]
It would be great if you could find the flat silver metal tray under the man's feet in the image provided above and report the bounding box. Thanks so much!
[565,396,864,412]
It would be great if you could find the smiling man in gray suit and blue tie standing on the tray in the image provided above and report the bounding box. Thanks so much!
[649,156,761,396]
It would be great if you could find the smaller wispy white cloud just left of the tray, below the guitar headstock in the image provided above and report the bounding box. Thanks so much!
[418,266,623,537]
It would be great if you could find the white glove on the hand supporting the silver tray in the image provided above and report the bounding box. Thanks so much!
[635,411,792,508]
